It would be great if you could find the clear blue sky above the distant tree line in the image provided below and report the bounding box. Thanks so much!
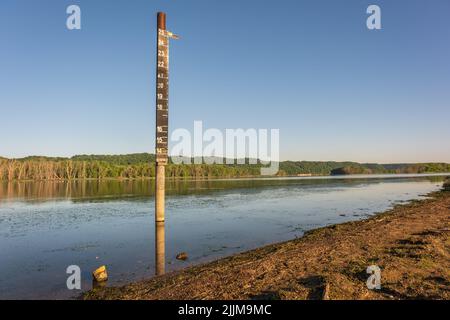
[0,0,450,163]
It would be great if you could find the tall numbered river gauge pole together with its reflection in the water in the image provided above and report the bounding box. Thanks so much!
[155,12,178,275]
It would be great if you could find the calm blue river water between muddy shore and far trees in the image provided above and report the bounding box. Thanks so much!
[0,175,443,299]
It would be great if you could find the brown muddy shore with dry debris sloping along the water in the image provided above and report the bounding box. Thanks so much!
[83,191,450,300]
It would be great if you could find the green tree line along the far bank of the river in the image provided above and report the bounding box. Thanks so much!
[0,153,450,181]
